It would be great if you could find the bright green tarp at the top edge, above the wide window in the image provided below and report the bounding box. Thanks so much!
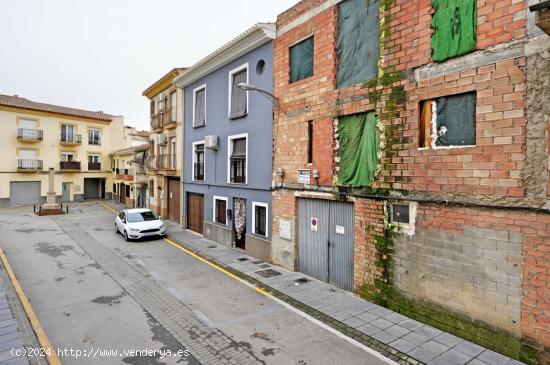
[432,0,477,62]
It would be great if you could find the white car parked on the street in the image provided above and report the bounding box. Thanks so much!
[115,209,167,241]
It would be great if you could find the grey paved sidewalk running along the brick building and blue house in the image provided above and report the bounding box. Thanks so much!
[161,209,532,365]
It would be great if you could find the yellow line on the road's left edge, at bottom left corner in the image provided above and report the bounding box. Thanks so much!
[0,248,61,365]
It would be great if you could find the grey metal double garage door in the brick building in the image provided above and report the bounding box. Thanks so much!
[298,199,354,290]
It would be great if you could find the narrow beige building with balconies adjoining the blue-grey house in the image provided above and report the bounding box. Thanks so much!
[143,68,186,224]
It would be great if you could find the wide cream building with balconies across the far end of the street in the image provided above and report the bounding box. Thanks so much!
[0,95,124,206]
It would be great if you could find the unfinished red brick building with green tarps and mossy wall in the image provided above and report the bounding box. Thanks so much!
[272,0,550,363]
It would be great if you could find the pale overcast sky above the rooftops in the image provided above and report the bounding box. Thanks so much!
[0,0,297,129]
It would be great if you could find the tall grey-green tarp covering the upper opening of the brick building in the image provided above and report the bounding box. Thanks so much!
[336,0,380,87]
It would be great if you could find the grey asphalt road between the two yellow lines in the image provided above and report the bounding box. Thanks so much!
[0,203,394,365]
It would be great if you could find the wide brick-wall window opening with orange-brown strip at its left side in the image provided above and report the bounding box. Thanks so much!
[418,92,476,148]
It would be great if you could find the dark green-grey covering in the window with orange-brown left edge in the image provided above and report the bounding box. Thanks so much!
[435,93,476,146]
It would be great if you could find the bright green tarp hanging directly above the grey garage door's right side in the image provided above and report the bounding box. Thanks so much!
[338,112,380,187]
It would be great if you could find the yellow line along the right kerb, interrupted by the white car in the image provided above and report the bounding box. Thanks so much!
[98,202,399,365]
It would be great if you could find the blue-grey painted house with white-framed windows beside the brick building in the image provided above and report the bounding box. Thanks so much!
[174,23,275,260]
